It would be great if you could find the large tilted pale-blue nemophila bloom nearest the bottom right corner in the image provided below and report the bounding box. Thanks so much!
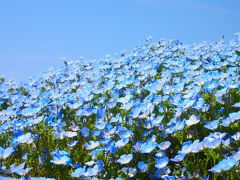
[209,157,238,173]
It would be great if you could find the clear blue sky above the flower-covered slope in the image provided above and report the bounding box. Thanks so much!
[0,0,240,81]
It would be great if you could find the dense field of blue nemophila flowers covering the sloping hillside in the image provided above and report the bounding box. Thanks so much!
[0,34,240,180]
